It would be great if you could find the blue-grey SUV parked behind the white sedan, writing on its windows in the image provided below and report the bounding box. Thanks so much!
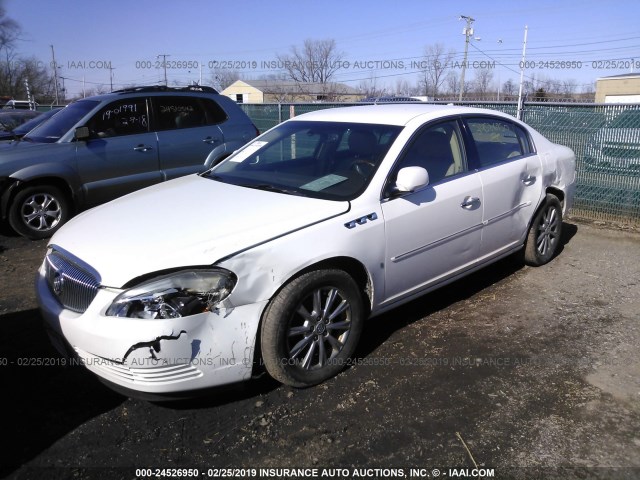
[0,86,258,239]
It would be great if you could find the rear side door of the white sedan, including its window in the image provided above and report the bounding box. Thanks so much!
[465,117,543,257]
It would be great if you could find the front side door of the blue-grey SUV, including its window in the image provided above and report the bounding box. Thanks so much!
[76,97,162,207]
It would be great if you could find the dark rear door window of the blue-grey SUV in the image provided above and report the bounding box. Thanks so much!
[152,96,227,130]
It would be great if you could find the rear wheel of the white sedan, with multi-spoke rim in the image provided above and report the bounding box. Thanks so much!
[524,194,562,267]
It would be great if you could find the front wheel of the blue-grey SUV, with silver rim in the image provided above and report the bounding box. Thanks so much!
[9,185,70,240]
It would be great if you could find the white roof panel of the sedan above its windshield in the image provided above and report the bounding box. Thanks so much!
[291,103,515,126]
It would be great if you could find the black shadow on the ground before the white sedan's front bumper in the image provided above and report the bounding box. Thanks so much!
[0,309,125,477]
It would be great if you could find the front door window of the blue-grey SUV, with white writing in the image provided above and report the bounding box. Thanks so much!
[88,97,149,138]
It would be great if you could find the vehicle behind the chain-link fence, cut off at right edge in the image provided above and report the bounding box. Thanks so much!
[585,108,640,176]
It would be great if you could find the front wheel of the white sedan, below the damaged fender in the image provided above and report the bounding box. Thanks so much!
[260,270,365,388]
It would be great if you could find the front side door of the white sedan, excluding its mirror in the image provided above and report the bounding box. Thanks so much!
[382,120,482,303]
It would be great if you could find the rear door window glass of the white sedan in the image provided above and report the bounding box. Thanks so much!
[466,118,531,167]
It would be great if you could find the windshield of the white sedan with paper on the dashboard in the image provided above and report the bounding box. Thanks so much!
[207,121,402,200]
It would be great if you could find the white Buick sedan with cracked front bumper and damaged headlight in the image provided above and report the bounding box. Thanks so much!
[37,104,575,396]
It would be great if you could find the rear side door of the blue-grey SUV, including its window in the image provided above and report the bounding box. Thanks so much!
[152,95,227,180]
